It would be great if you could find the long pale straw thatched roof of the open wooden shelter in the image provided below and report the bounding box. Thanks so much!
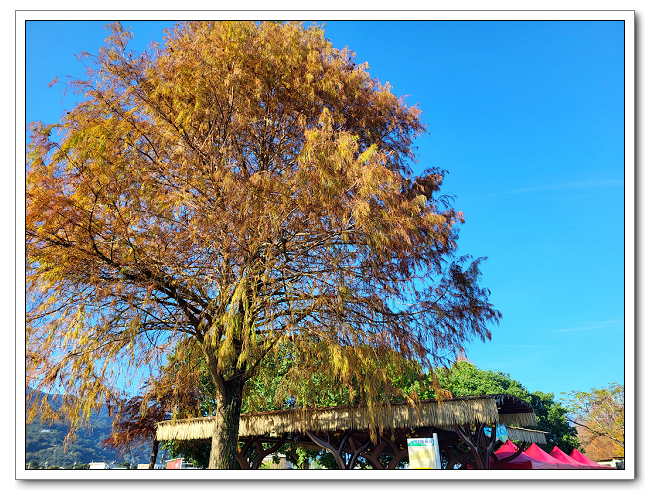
[156,395,536,441]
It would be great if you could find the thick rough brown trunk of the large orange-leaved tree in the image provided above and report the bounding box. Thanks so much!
[208,378,244,469]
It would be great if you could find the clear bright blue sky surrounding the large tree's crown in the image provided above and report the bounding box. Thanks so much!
[26,21,624,398]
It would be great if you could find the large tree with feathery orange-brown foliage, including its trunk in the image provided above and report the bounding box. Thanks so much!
[26,22,500,468]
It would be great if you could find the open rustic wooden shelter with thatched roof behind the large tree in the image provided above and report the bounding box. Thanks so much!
[156,395,546,469]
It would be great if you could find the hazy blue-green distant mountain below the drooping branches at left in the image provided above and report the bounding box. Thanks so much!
[25,391,150,467]
